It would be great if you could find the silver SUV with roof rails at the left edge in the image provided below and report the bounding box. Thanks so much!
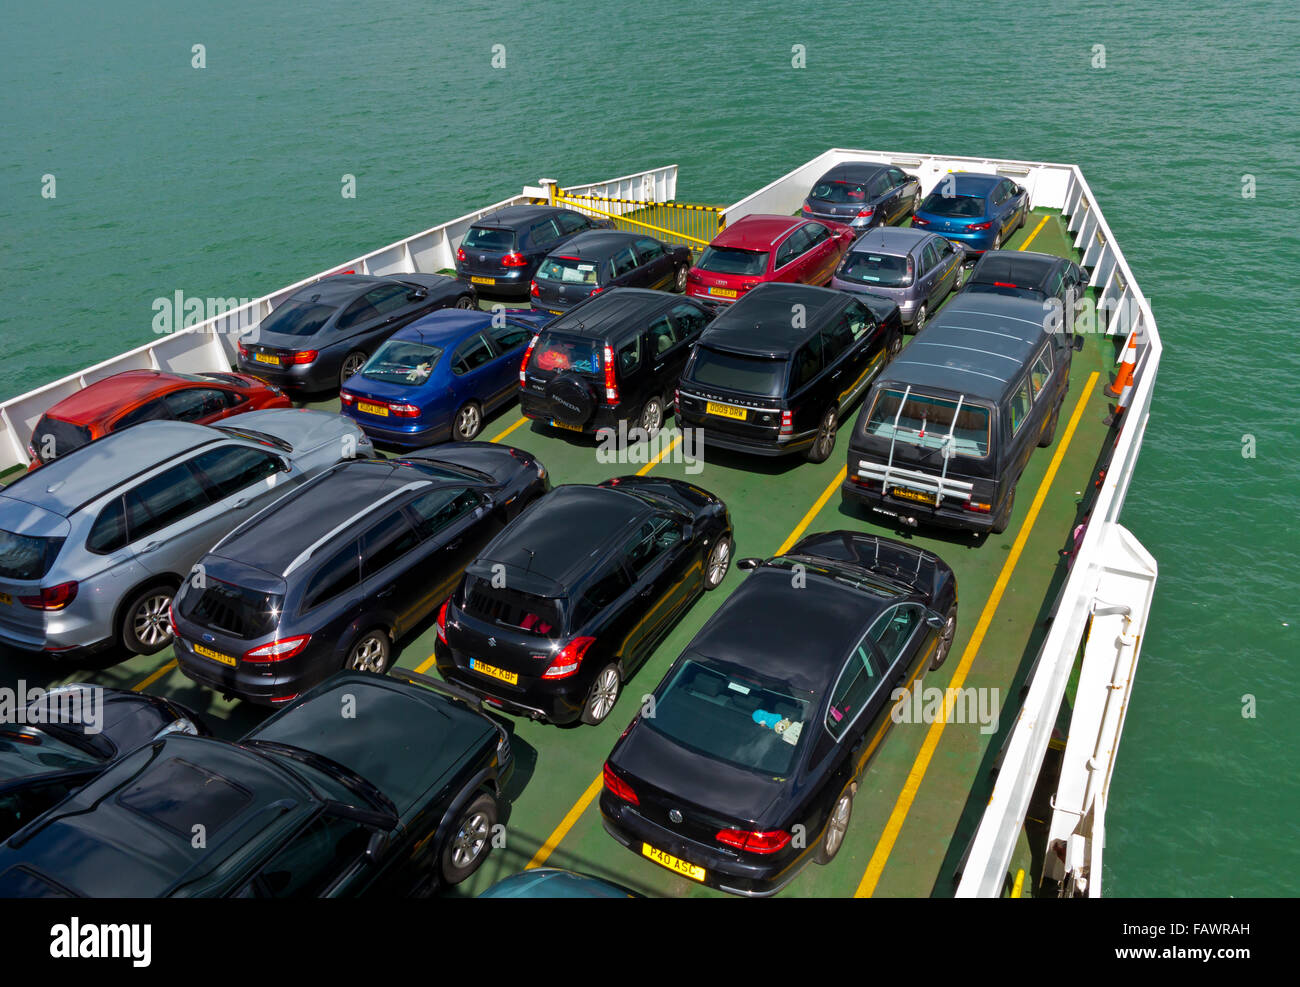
[0,408,373,658]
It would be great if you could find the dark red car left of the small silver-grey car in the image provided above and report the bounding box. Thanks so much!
[686,213,857,304]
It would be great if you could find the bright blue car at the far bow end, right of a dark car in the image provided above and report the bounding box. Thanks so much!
[911,172,1030,254]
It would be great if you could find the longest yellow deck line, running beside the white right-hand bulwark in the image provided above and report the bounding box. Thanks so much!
[854,371,1100,897]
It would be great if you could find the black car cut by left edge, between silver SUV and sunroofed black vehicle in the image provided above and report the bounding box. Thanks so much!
[0,683,208,840]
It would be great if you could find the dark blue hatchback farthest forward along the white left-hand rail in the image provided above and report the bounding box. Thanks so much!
[456,205,614,298]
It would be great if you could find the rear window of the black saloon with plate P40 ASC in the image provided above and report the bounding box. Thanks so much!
[642,655,816,778]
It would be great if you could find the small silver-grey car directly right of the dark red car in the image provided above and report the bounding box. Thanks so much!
[831,226,966,333]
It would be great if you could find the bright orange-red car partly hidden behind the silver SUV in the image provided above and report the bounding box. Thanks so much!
[27,371,293,469]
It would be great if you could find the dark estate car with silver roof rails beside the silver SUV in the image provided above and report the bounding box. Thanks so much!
[172,442,550,705]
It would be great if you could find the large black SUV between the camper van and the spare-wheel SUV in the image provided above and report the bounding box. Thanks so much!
[677,282,902,463]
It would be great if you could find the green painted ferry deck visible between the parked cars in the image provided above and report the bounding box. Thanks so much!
[0,211,1115,896]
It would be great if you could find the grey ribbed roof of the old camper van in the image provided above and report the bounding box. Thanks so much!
[875,291,1048,401]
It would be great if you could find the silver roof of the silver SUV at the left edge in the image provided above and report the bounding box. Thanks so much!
[0,421,220,516]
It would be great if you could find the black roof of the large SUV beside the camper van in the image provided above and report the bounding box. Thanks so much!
[699,281,850,356]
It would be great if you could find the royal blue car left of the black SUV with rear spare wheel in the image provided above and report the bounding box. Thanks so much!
[339,308,554,449]
